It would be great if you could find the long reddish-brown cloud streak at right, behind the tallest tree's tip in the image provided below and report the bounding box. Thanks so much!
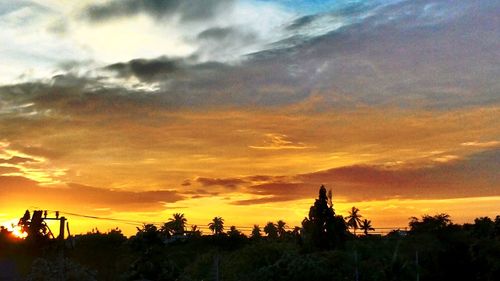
[234,150,500,205]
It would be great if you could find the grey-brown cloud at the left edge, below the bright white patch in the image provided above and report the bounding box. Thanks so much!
[0,74,164,117]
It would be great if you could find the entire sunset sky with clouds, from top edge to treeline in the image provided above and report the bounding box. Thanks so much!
[0,0,500,235]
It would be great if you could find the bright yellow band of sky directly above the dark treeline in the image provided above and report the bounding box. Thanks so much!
[0,196,500,237]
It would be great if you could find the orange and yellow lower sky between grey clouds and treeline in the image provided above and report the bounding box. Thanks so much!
[0,104,500,234]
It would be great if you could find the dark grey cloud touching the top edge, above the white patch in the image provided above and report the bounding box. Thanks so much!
[85,0,233,22]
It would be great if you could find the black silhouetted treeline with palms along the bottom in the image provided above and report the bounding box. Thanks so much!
[0,185,500,281]
